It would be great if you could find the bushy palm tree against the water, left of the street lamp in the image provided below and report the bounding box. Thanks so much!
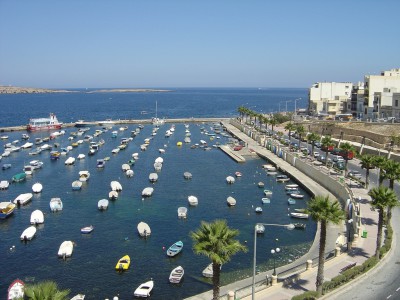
[190,220,247,300]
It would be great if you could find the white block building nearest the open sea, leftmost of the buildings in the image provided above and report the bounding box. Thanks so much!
[309,82,353,116]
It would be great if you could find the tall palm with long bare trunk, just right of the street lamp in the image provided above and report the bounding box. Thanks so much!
[306,196,344,295]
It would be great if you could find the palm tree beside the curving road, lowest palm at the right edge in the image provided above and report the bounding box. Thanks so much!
[368,185,398,259]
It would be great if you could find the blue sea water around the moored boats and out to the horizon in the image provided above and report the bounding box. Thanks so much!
[0,88,317,299]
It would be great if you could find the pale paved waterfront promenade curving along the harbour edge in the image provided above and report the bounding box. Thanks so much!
[187,122,378,300]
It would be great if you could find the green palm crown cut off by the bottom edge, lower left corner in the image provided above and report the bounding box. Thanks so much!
[25,281,70,300]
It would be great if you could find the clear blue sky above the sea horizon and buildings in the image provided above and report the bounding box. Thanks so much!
[0,0,400,88]
